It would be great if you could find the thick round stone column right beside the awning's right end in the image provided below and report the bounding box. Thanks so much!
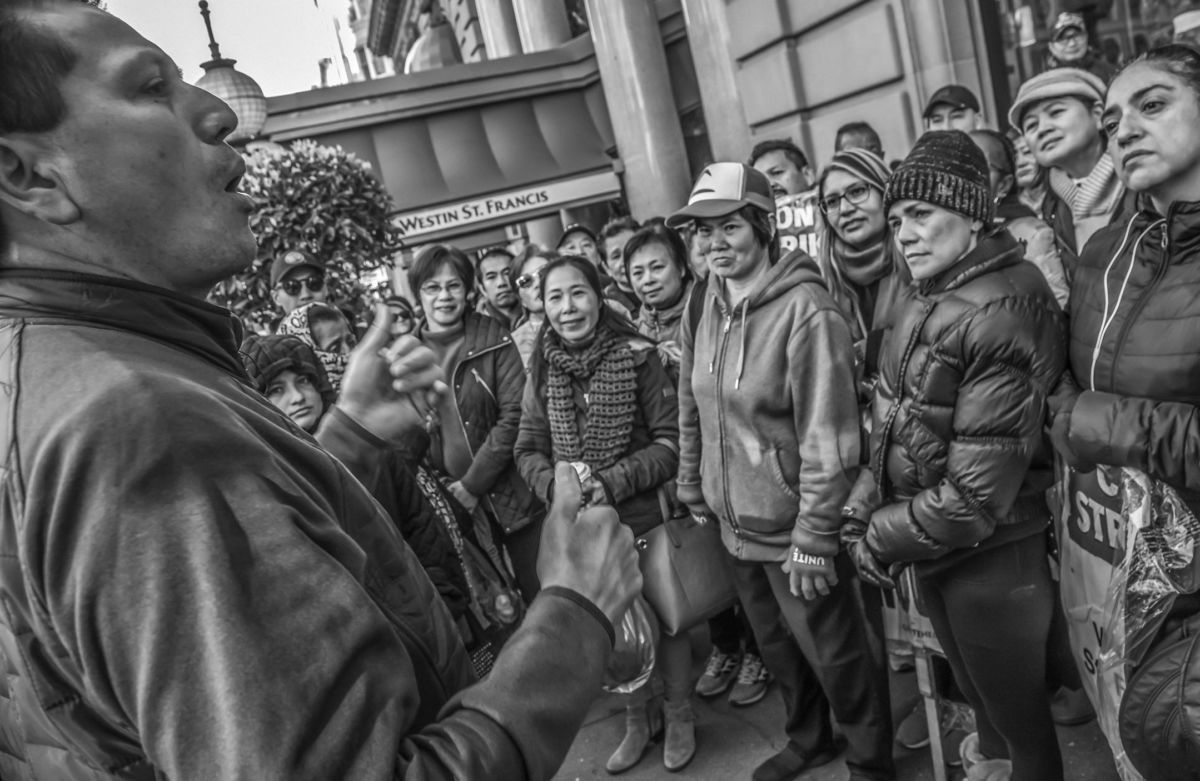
[588,0,691,220]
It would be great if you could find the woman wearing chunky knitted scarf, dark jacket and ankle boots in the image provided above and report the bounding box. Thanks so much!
[516,256,696,773]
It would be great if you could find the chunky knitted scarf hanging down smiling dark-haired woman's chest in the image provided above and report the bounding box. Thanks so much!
[541,325,637,469]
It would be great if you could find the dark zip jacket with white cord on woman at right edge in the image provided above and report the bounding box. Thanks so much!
[1068,202,1200,512]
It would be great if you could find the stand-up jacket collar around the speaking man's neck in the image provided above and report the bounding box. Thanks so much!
[0,269,246,378]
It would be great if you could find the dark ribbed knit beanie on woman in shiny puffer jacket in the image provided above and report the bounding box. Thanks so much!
[883,131,994,223]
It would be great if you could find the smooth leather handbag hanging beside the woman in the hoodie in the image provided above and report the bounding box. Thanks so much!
[637,513,738,635]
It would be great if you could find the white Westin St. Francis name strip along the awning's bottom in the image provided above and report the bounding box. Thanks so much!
[391,170,620,239]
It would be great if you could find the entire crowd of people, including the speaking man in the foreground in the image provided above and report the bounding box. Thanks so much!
[0,0,1200,781]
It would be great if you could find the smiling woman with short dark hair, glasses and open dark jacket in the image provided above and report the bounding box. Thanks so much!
[408,245,545,600]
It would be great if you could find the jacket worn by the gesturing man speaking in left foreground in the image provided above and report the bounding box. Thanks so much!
[0,270,611,781]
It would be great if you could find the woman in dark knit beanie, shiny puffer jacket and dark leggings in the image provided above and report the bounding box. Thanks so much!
[845,131,1066,781]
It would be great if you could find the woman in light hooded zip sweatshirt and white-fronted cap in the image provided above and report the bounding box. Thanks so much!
[668,163,893,781]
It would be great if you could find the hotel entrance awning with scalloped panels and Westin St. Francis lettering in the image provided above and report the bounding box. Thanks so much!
[265,38,620,244]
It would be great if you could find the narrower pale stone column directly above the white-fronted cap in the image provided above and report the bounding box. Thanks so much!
[683,0,752,162]
